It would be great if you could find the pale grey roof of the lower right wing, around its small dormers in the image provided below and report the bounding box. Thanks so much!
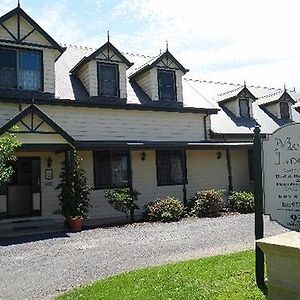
[184,79,300,136]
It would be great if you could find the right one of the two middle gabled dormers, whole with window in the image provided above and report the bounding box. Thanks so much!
[129,49,189,103]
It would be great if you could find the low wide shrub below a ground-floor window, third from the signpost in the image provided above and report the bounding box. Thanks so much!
[144,196,183,222]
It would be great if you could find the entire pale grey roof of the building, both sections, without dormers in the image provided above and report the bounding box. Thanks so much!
[55,46,300,134]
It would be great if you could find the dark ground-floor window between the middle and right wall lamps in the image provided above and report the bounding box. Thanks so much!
[156,150,186,185]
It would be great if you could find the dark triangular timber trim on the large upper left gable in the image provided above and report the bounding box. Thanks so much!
[0,5,66,54]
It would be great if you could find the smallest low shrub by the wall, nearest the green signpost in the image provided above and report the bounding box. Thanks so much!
[228,191,254,214]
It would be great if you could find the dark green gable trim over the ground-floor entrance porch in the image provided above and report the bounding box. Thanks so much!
[0,104,74,144]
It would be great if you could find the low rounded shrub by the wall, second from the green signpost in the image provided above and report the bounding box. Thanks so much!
[188,189,223,217]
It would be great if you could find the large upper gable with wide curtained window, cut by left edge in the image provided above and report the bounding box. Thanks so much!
[0,6,65,96]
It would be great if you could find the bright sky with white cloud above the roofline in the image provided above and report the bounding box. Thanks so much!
[0,0,300,92]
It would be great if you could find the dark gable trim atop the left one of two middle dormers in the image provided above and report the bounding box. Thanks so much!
[70,41,133,73]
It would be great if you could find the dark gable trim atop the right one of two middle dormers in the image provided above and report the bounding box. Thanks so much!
[129,49,189,78]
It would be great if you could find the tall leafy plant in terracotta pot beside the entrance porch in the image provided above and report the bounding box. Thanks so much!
[55,153,91,232]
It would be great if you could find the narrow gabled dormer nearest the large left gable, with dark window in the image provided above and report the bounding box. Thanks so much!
[71,41,132,100]
